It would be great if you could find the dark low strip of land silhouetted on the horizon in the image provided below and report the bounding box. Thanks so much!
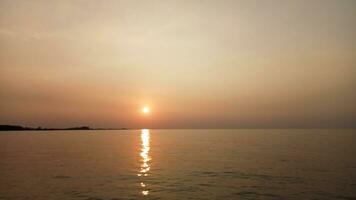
[0,125,128,131]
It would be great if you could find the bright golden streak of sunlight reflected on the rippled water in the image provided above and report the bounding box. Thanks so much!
[137,129,151,196]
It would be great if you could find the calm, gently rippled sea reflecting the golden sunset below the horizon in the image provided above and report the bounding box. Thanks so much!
[0,129,356,200]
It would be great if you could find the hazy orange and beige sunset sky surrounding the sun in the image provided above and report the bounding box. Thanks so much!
[0,0,356,128]
